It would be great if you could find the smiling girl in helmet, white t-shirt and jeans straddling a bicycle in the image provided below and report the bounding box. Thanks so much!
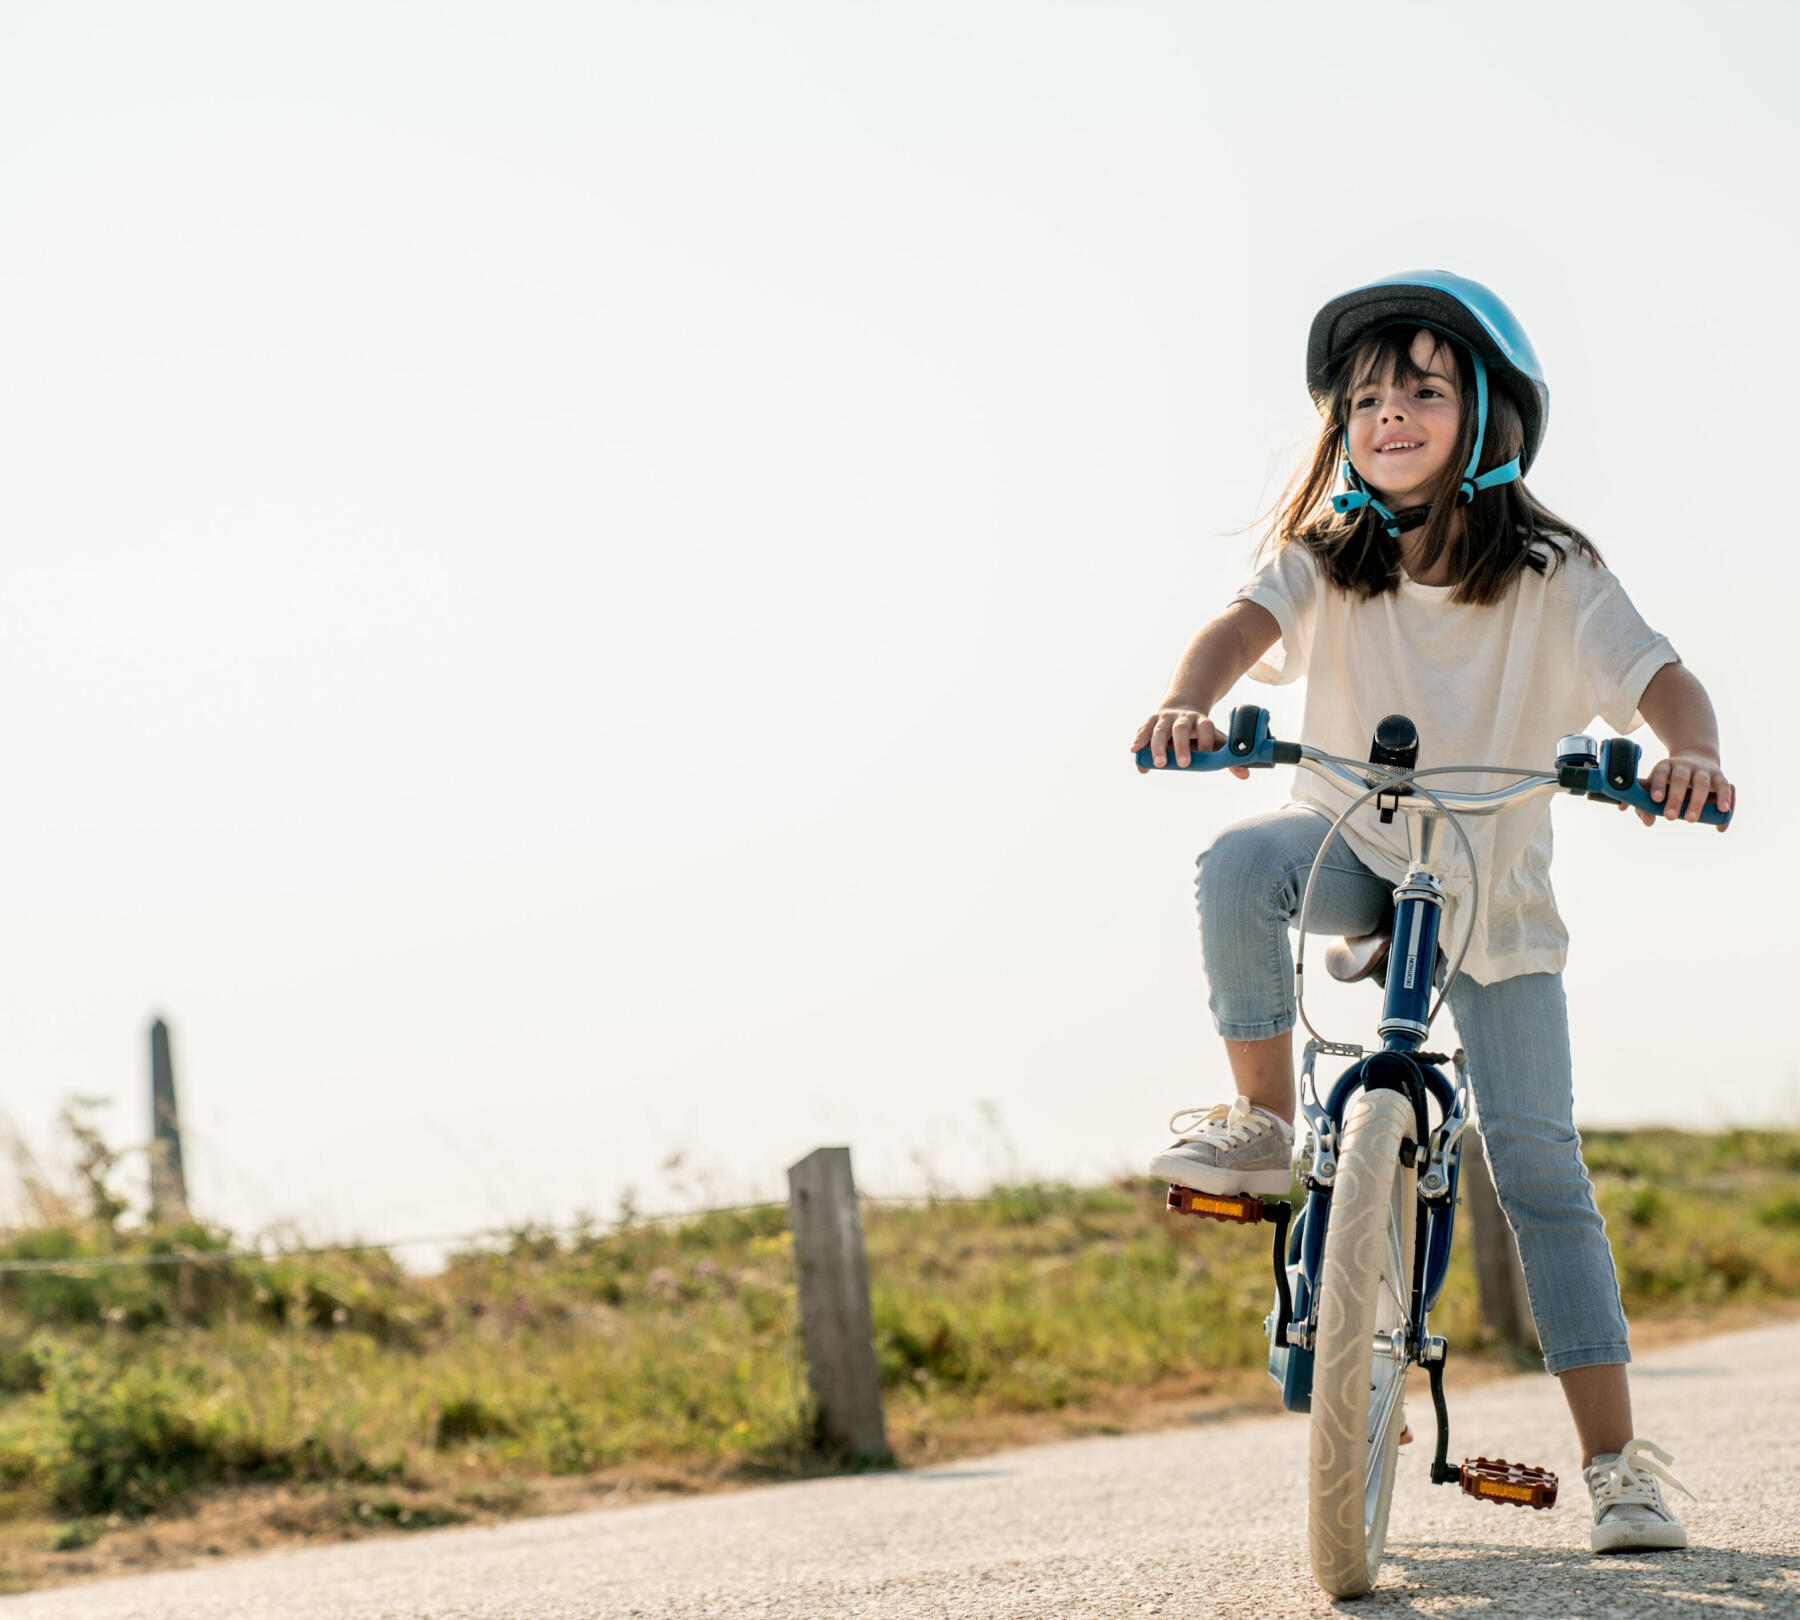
[1132,270,1732,1552]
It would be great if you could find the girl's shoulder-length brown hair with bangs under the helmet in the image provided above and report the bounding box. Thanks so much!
[1264,324,1602,603]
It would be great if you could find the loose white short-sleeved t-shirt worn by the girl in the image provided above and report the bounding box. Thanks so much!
[1235,544,1679,985]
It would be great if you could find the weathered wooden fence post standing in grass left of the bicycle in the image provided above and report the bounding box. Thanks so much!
[788,1148,893,1462]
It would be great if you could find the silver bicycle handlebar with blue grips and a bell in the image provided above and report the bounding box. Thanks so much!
[1138,706,1733,826]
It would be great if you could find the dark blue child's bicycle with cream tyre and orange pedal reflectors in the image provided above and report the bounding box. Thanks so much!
[1138,706,1732,1597]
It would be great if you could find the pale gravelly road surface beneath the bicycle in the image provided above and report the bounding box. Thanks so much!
[0,1325,1800,1620]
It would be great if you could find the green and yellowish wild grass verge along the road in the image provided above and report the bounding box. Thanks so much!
[0,1130,1800,1586]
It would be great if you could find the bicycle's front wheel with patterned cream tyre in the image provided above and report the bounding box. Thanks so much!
[1307,1091,1418,1597]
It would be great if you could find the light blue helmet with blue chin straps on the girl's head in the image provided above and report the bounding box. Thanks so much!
[1307,270,1550,533]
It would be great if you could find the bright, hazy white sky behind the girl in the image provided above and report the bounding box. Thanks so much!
[0,0,1800,1235]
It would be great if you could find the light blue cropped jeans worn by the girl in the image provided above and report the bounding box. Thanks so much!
[1195,805,1631,1373]
